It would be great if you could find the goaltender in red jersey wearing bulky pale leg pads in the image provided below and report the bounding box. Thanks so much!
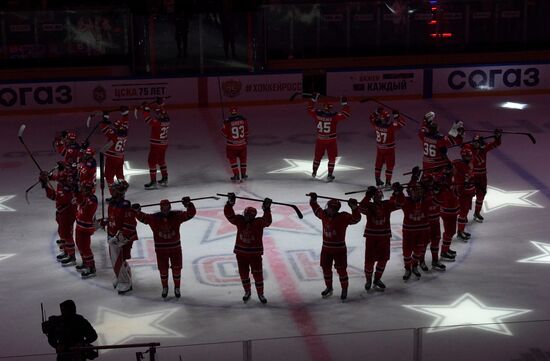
[101,179,137,295]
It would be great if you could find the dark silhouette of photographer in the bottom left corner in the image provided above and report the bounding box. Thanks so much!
[42,300,98,361]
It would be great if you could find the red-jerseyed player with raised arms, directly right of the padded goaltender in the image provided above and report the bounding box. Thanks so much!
[132,197,197,298]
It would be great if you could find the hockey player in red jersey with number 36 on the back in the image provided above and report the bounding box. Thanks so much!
[418,112,464,174]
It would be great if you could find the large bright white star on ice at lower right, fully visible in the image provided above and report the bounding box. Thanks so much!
[403,293,531,336]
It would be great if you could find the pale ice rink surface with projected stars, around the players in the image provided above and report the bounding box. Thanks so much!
[0,95,550,361]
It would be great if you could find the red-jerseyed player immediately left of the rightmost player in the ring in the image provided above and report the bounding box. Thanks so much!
[453,144,475,242]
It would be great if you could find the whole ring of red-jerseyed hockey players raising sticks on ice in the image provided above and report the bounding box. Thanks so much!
[39,94,502,304]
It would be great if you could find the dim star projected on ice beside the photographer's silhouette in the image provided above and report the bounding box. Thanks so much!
[93,306,184,345]
